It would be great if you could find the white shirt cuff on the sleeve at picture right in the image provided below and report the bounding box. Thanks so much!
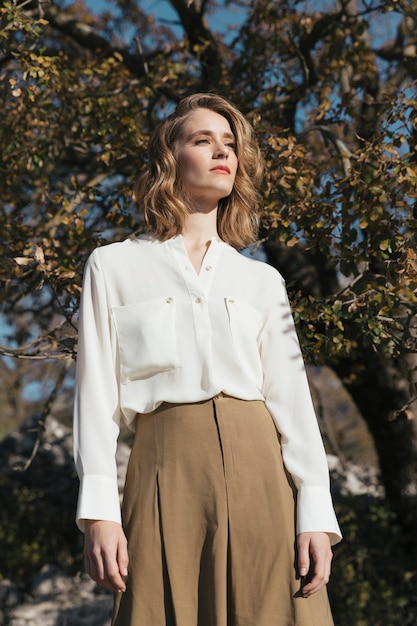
[297,485,342,545]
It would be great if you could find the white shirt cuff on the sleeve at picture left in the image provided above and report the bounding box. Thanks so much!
[76,475,122,532]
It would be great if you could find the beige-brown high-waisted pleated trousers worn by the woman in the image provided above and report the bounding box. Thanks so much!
[113,394,333,626]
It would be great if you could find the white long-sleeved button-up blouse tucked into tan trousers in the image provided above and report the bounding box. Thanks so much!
[74,236,341,543]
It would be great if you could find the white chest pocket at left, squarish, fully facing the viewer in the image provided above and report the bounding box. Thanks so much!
[111,298,180,384]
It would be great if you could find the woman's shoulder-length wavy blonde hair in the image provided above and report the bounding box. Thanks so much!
[135,93,263,248]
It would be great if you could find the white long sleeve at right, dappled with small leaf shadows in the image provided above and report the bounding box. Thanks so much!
[260,275,341,543]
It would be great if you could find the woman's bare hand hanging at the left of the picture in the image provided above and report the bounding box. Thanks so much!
[84,520,129,592]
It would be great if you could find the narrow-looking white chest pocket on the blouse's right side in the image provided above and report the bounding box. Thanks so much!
[225,298,263,389]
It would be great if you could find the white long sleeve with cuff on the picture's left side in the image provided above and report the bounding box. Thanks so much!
[74,251,120,530]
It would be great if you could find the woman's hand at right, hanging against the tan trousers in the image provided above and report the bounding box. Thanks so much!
[297,532,333,598]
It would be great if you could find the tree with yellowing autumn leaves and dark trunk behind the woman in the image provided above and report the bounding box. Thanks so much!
[0,0,417,620]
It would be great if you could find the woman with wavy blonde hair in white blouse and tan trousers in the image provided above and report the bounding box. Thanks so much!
[74,94,340,626]
